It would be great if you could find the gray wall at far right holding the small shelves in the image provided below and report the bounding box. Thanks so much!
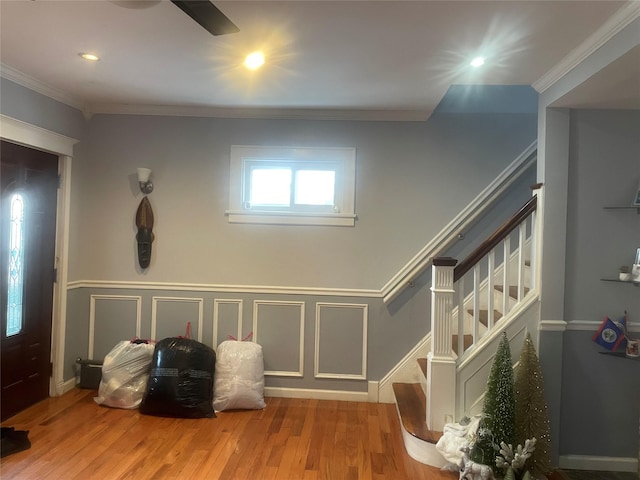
[560,110,640,458]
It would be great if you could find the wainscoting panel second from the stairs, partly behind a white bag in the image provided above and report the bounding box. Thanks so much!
[253,300,305,377]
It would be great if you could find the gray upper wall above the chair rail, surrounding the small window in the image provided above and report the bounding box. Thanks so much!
[69,114,536,289]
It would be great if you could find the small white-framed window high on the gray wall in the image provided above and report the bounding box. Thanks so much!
[227,145,356,226]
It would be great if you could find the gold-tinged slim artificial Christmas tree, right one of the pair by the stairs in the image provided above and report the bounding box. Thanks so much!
[514,334,551,476]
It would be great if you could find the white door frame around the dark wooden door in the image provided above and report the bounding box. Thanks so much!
[0,114,79,397]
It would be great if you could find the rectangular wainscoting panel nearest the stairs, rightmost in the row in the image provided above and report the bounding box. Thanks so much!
[314,302,369,380]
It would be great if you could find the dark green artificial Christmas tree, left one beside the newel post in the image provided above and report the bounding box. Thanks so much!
[470,332,516,470]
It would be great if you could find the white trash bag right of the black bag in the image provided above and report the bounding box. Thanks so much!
[213,340,266,412]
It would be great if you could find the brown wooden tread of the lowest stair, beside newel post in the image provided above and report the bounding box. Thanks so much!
[393,383,442,443]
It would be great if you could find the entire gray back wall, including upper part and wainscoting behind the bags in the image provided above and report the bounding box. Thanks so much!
[65,107,536,392]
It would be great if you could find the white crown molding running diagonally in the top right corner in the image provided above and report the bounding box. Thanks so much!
[532,0,640,93]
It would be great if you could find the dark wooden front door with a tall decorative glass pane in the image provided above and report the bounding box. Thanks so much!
[0,141,58,420]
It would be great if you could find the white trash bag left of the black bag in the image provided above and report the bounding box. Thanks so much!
[94,340,154,409]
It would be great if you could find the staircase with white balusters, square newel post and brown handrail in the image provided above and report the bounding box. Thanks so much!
[393,185,542,467]
